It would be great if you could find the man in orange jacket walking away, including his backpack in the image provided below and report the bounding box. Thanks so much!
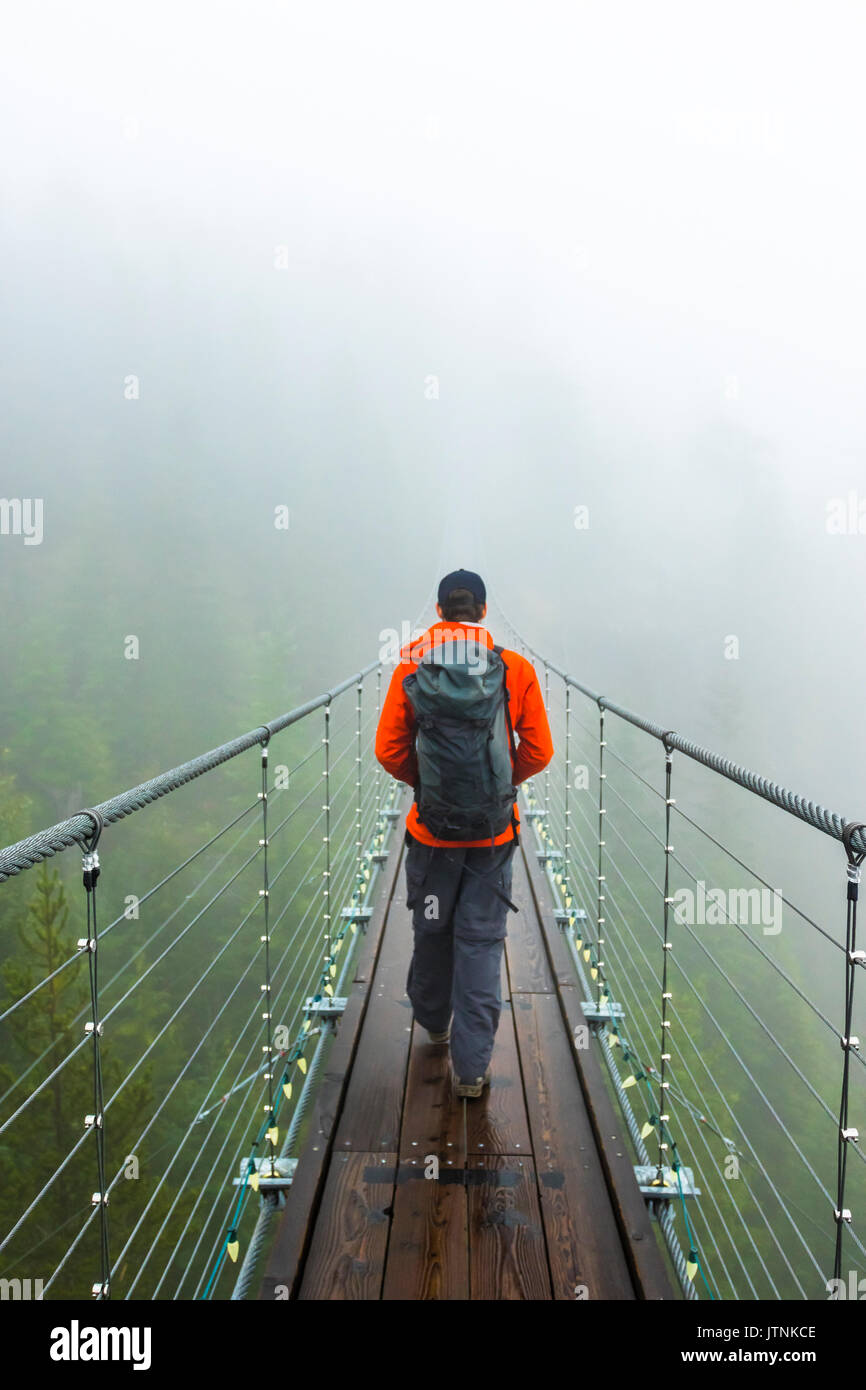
[375,570,553,1097]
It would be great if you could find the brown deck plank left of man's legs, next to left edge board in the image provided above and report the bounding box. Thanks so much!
[334,870,413,1154]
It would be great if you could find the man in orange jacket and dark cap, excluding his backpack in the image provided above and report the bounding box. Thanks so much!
[375,570,553,1098]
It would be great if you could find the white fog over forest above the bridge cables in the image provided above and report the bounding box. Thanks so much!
[0,3,866,922]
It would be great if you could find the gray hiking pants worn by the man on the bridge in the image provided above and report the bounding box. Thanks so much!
[406,834,516,1080]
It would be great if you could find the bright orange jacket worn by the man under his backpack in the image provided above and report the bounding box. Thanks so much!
[375,621,553,849]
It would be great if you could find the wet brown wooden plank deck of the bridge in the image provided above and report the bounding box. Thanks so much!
[260,811,678,1300]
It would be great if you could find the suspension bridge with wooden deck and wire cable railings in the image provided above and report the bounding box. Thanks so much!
[0,589,866,1301]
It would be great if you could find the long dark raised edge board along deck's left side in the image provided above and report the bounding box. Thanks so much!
[259,806,402,1301]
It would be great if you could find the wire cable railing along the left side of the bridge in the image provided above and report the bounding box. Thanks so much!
[0,639,419,1300]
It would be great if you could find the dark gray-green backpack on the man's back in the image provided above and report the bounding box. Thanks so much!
[403,638,517,845]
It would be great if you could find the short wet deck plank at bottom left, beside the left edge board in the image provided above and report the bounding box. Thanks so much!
[299,1152,396,1301]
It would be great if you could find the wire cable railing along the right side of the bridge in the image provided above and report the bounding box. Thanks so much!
[493,599,866,1298]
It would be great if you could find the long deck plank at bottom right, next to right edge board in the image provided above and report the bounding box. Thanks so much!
[514,994,634,1300]
